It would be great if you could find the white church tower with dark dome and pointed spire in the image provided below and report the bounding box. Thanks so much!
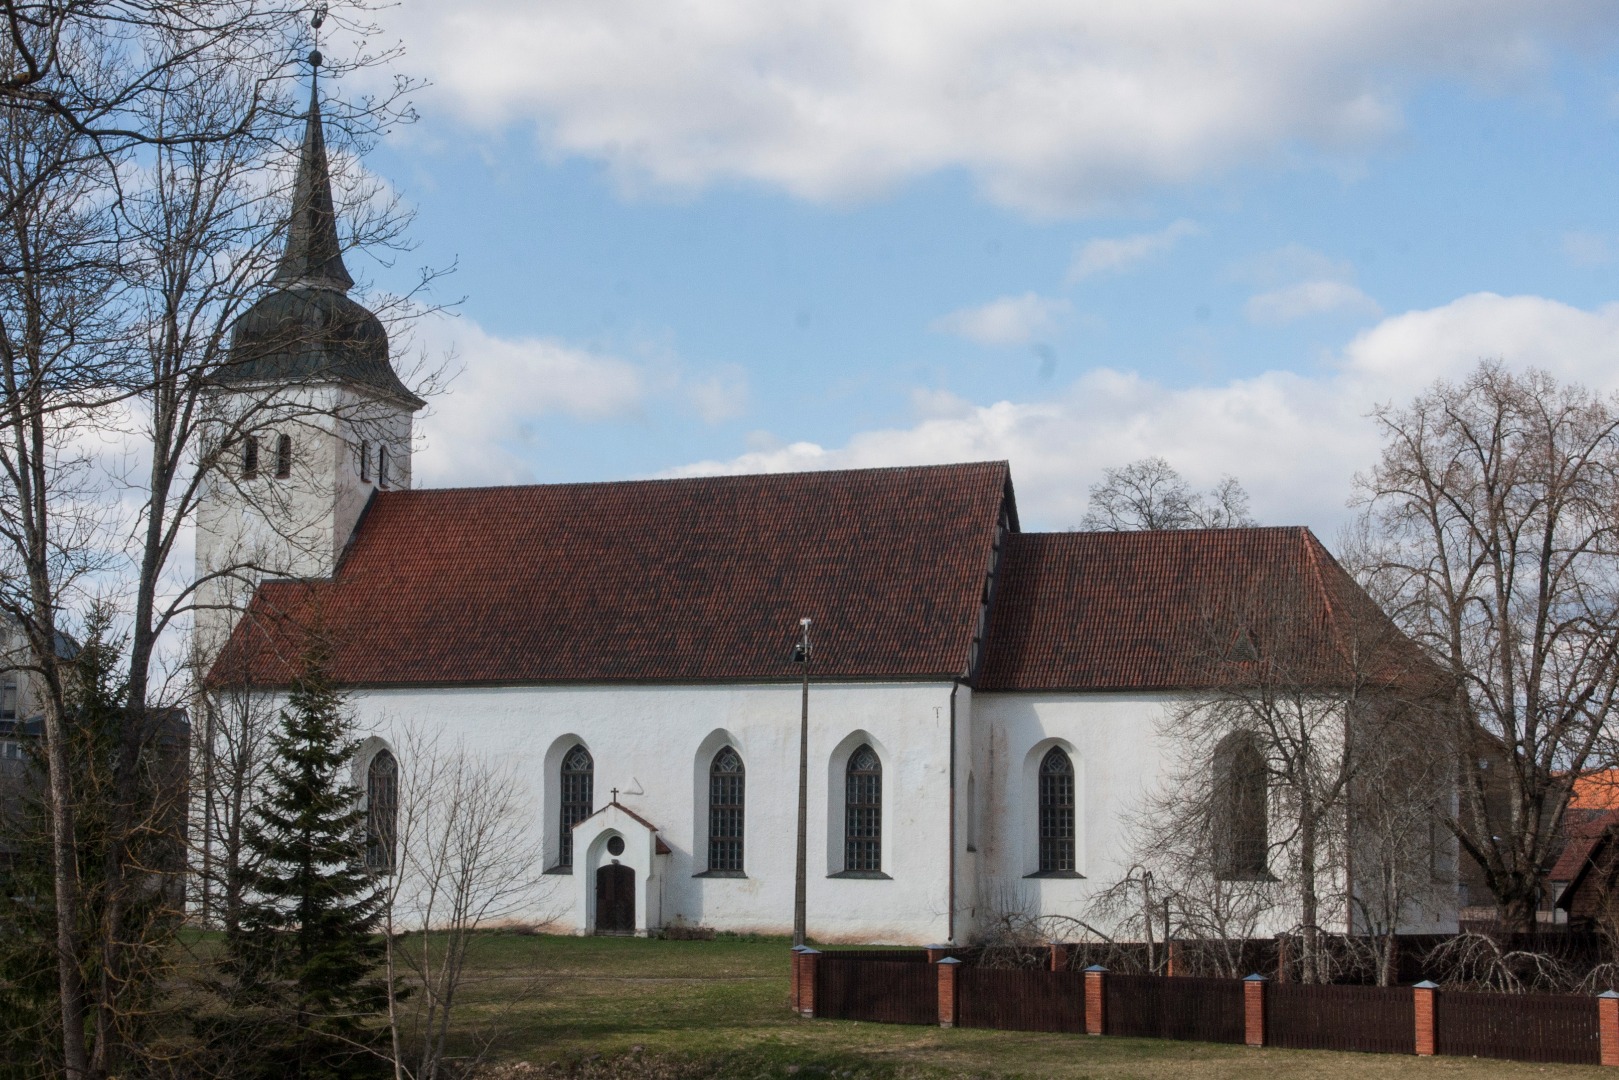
[196,67,424,656]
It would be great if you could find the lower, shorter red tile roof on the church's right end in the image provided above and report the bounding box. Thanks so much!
[978,528,1431,690]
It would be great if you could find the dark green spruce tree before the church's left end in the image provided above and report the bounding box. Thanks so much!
[227,641,392,1080]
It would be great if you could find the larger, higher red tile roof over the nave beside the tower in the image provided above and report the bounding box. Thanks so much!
[214,461,1017,687]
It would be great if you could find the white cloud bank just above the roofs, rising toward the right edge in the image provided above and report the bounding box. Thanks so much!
[663,293,1619,542]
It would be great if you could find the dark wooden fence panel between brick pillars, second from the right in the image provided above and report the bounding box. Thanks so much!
[1264,983,1417,1054]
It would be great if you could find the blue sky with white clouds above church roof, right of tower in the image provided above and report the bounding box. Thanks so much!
[348,0,1619,538]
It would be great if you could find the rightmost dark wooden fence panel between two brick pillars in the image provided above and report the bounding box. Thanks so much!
[1434,991,1603,1065]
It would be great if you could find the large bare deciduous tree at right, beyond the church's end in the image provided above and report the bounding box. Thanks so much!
[1357,363,1619,929]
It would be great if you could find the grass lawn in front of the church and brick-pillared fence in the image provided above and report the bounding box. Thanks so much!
[440,933,1604,1080]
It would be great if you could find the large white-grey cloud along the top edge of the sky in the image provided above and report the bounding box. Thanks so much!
[390,0,1616,214]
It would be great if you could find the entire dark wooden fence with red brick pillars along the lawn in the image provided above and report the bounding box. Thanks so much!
[793,949,1619,1064]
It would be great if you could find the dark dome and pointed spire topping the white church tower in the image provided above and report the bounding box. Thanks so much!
[217,76,423,408]
